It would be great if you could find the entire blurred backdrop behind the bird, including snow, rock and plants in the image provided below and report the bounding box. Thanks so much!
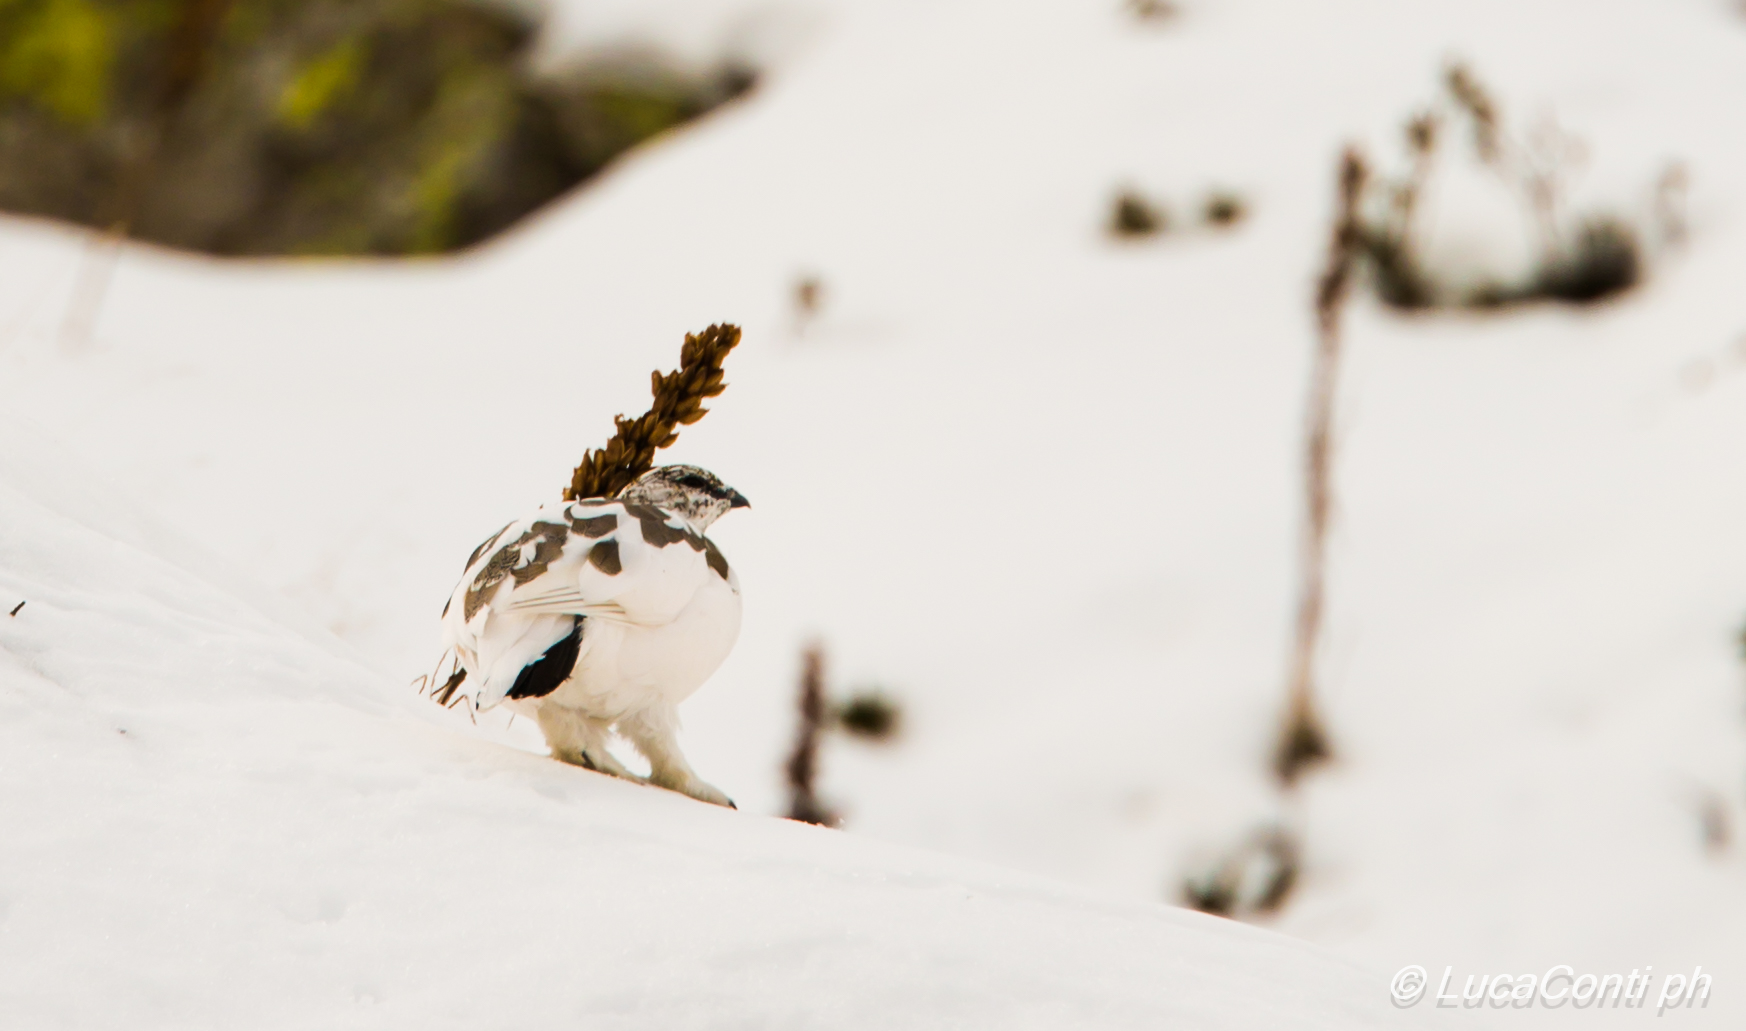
[0,0,1746,1022]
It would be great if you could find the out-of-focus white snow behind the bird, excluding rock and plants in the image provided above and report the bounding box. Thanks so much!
[0,0,1746,1026]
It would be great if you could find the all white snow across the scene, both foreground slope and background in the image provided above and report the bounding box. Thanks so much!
[0,0,1746,1026]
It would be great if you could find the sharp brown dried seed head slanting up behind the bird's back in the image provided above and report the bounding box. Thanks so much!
[564,323,740,502]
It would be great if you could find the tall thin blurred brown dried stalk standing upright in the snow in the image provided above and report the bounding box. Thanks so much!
[1275,149,1367,785]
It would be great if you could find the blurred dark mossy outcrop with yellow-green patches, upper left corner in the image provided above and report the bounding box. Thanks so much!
[0,0,751,255]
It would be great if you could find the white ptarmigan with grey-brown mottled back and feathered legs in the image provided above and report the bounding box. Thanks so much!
[443,465,747,806]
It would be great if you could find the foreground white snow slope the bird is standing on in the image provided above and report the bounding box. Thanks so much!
[0,425,1402,1031]
